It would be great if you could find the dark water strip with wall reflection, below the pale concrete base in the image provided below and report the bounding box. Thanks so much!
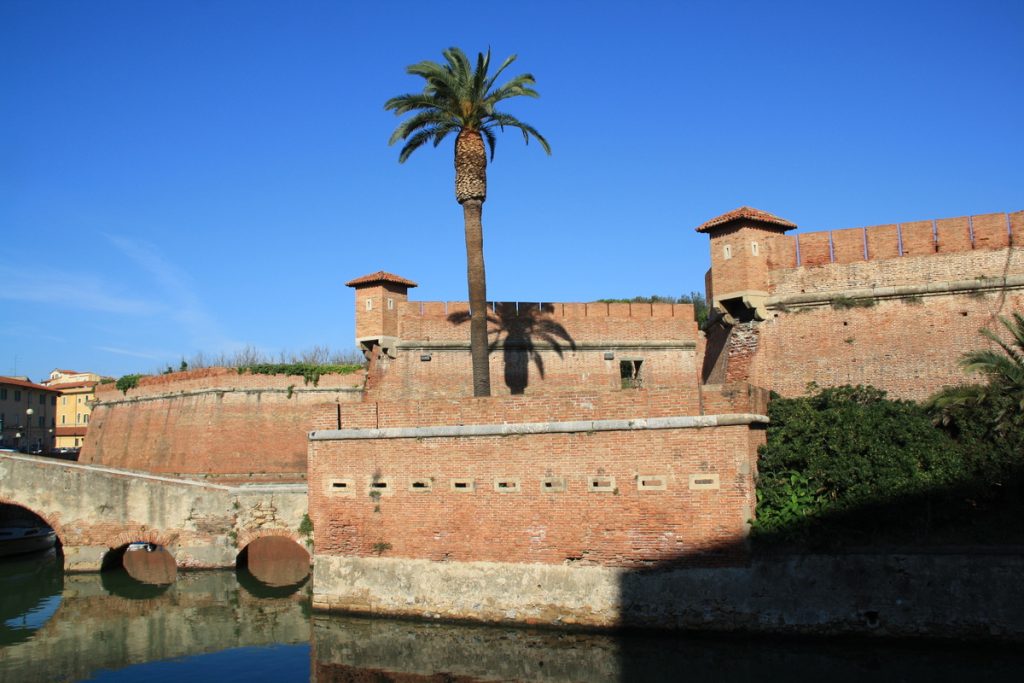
[312,614,1024,683]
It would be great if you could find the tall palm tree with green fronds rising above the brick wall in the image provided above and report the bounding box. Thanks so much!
[384,47,551,396]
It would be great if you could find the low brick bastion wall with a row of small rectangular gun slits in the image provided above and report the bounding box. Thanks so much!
[309,385,766,566]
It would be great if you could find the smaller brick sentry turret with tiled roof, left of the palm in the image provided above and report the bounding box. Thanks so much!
[345,270,416,354]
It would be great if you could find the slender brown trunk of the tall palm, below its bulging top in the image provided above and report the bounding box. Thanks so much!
[462,200,490,396]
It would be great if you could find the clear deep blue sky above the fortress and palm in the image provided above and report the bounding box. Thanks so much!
[0,0,1024,380]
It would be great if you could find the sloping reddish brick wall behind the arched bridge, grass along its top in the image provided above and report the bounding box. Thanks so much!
[80,368,365,479]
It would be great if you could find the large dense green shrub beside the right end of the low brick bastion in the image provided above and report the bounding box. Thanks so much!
[754,386,963,541]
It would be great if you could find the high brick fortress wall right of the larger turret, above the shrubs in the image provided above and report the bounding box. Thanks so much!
[705,212,1024,399]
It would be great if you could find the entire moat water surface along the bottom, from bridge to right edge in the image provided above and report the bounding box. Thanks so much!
[0,552,1024,683]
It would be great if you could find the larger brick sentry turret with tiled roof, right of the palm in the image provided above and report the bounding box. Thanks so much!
[696,206,797,319]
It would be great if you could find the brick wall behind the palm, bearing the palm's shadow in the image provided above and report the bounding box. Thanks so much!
[357,297,698,397]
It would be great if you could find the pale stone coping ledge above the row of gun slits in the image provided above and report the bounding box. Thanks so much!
[309,413,768,441]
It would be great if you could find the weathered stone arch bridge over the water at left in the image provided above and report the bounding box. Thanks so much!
[0,454,311,571]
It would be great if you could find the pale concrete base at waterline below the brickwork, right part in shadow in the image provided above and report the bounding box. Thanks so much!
[313,554,1024,641]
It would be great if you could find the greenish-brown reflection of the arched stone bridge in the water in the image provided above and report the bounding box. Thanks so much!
[0,565,309,683]
